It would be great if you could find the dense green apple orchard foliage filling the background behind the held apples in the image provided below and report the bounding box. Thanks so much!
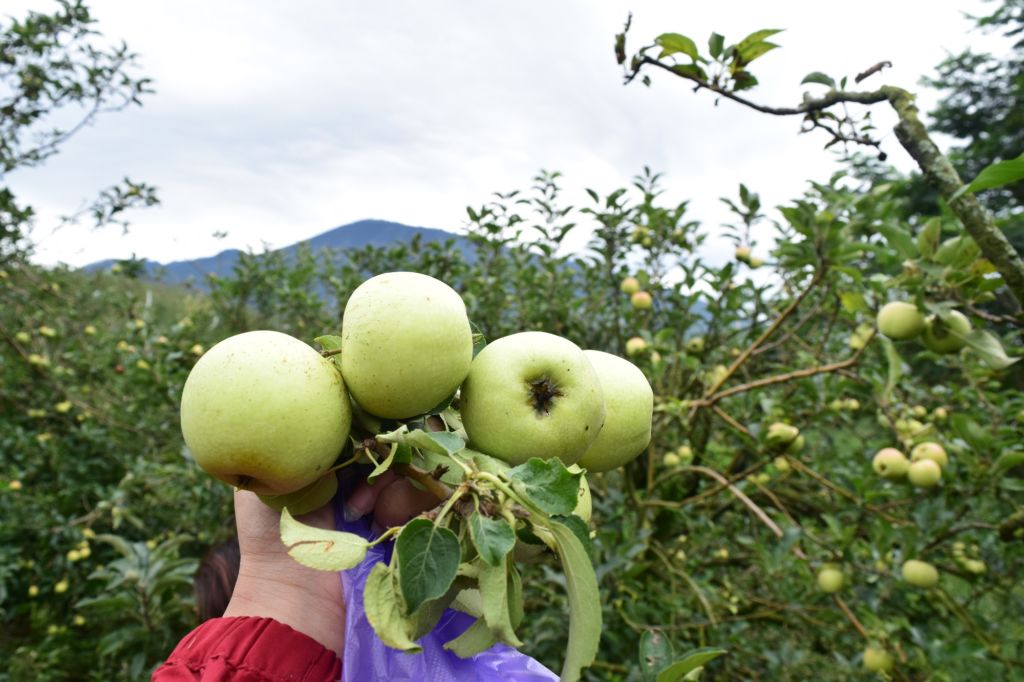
[0,1,1024,681]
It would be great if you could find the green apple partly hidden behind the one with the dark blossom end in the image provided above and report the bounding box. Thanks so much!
[580,350,654,472]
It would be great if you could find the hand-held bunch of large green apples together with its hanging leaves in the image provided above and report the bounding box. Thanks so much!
[181,272,653,682]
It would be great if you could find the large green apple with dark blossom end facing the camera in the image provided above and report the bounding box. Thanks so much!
[460,332,606,465]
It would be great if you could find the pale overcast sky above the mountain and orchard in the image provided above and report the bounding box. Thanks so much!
[6,0,993,265]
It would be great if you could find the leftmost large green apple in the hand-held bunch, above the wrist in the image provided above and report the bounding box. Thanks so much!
[181,331,352,495]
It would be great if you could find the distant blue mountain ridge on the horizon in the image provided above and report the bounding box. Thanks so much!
[83,220,471,288]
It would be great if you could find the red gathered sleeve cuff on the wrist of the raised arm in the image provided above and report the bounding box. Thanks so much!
[153,616,341,682]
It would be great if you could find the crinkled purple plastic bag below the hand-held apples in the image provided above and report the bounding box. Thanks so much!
[335,476,558,682]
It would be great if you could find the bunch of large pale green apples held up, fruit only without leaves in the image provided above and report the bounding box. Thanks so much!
[181,272,653,501]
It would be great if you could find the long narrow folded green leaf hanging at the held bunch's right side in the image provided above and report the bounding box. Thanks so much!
[551,521,601,682]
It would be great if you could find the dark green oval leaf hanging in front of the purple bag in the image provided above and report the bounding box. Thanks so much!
[394,518,462,613]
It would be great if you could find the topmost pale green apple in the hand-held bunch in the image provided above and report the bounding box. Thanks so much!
[341,272,473,419]
